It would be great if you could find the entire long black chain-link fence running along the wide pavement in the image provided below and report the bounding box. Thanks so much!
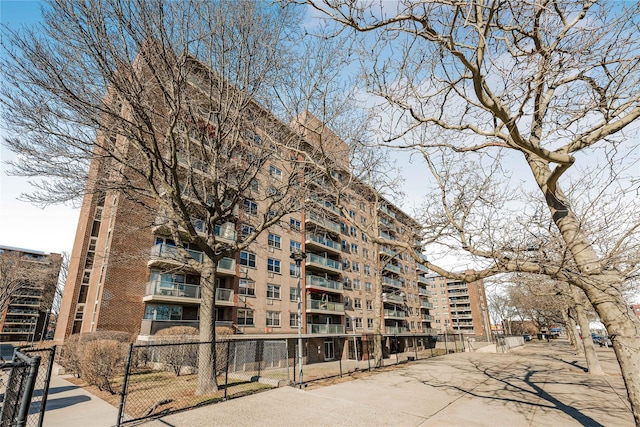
[114,334,492,425]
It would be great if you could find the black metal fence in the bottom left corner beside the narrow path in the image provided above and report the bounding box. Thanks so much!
[0,347,56,427]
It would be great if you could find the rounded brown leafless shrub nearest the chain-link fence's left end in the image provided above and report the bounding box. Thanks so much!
[81,339,127,394]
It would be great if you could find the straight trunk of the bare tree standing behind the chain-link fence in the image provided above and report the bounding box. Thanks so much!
[196,259,218,394]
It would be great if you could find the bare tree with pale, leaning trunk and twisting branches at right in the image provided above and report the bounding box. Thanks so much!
[305,0,640,425]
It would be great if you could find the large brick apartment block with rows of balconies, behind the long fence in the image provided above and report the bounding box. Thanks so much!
[55,53,433,360]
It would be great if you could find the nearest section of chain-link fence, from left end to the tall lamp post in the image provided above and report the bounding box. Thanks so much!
[118,340,290,425]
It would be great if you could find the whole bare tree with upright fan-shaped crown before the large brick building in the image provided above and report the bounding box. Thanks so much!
[0,0,350,393]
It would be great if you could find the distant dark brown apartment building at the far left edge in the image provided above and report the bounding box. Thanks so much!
[0,246,62,342]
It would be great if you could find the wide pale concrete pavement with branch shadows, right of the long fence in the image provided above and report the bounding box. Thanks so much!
[134,341,634,427]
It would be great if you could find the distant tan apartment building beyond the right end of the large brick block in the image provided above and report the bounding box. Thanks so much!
[427,274,491,336]
